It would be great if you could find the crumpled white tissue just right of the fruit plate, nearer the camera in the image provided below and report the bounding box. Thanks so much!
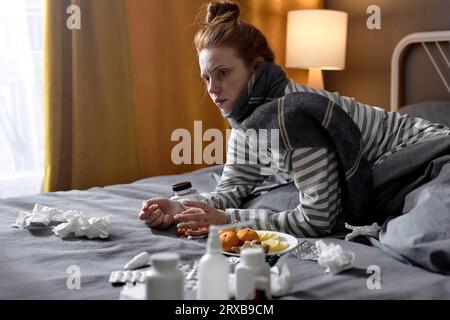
[316,240,355,274]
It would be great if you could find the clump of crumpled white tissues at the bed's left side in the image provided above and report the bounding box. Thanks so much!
[13,204,111,239]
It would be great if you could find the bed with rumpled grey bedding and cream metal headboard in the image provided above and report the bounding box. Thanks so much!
[0,31,450,300]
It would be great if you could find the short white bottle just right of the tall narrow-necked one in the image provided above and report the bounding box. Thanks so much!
[235,248,271,300]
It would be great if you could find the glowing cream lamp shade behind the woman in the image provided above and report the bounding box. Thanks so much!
[286,10,348,70]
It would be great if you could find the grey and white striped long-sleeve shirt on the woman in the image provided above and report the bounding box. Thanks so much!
[203,81,450,237]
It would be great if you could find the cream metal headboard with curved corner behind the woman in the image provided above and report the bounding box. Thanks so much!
[391,30,450,111]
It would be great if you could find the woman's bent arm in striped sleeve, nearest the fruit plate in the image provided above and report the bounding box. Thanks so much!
[226,148,341,237]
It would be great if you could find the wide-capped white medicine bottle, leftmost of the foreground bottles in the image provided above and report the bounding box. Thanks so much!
[145,252,184,300]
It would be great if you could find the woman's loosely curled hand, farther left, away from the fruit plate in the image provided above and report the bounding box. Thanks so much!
[139,198,184,229]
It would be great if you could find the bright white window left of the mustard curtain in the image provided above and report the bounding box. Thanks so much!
[0,0,44,198]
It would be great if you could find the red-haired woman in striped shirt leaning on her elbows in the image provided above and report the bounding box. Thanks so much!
[139,2,450,237]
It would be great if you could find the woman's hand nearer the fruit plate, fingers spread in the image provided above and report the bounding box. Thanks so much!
[174,200,227,236]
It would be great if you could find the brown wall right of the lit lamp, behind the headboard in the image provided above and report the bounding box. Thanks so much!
[324,0,450,109]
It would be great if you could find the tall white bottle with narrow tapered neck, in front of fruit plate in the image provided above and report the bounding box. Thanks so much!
[197,225,230,300]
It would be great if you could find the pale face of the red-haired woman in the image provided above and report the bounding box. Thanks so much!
[199,47,252,113]
